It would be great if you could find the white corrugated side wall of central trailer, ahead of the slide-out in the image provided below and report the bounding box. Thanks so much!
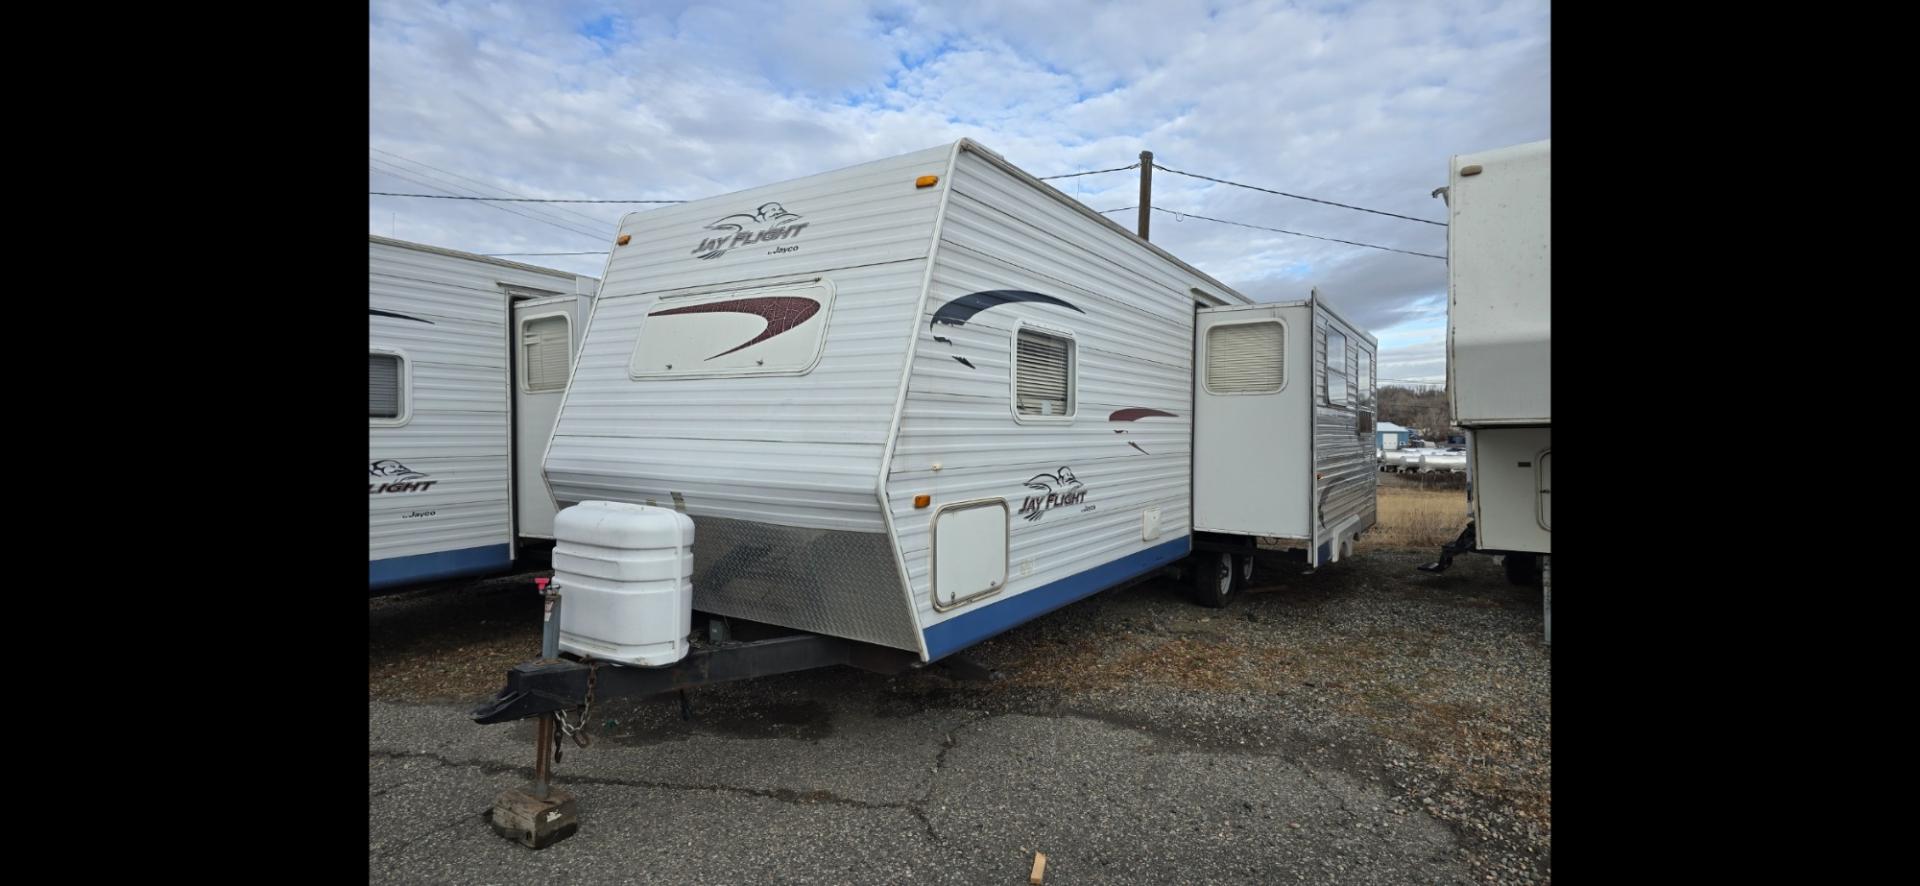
[887,152,1244,628]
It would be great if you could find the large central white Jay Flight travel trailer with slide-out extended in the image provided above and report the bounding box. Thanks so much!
[545,140,1377,661]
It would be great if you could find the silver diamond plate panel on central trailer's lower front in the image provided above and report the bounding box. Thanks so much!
[693,517,920,650]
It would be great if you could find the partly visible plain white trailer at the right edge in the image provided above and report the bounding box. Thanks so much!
[1434,142,1553,642]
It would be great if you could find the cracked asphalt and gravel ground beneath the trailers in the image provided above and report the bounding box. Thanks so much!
[369,550,1551,884]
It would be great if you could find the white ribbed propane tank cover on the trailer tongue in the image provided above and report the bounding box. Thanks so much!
[553,502,693,667]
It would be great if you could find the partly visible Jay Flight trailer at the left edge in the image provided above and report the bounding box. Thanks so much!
[367,234,599,590]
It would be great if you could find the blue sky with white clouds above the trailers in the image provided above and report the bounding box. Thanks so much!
[367,0,1551,381]
